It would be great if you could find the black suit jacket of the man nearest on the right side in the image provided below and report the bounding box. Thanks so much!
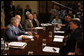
[60,28,81,55]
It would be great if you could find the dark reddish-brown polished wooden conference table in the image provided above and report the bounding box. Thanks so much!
[1,23,65,55]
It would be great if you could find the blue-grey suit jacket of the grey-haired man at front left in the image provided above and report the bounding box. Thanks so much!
[4,24,25,41]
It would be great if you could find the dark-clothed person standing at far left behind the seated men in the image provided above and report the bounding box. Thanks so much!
[4,1,15,26]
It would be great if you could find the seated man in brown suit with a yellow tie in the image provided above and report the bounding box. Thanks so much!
[24,14,34,31]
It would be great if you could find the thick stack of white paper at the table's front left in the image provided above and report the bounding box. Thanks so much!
[8,42,27,49]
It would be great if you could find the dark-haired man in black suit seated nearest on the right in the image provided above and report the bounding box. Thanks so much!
[61,20,81,55]
